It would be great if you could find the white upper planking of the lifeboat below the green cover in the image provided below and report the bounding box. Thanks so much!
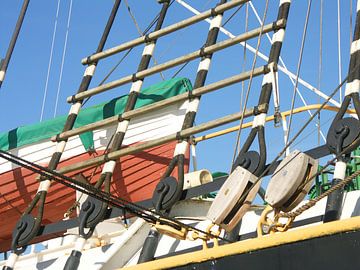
[0,101,188,173]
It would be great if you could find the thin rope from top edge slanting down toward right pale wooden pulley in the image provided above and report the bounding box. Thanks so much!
[285,0,312,151]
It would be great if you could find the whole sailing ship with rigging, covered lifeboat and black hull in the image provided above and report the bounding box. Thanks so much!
[0,0,360,270]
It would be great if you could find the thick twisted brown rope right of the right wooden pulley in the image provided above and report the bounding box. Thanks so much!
[279,170,360,218]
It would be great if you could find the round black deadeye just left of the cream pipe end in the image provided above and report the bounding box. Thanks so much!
[152,176,178,210]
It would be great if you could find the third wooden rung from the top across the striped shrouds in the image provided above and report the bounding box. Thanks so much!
[51,66,268,141]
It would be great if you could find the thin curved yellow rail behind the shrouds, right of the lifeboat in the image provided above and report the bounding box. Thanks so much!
[194,104,355,143]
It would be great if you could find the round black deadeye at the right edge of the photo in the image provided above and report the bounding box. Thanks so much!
[326,117,360,154]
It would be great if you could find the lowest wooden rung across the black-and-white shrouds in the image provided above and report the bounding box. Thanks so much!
[57,105,267,174]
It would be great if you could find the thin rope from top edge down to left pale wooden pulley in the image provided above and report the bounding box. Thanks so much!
[230,0,269,168]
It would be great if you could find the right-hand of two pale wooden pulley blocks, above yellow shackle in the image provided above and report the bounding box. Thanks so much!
[265,150,318,212]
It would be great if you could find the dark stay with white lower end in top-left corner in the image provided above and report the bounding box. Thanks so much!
[0,0,30,88]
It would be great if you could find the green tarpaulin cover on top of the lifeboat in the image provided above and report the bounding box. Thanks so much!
[0,78,192,151]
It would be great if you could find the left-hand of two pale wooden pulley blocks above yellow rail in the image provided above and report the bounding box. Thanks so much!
[206,166,260,231]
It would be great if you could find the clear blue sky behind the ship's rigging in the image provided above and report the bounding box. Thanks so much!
[0,0,356,177]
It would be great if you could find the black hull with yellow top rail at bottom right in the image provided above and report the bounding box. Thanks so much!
[150,217,360,270]
